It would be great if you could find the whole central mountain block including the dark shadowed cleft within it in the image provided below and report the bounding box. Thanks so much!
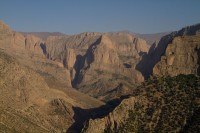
[46,33,148,98]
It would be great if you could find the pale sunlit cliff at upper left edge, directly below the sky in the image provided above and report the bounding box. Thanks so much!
[0,21,44,56]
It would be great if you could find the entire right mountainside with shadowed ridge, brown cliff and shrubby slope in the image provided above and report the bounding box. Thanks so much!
[82,24,200,133]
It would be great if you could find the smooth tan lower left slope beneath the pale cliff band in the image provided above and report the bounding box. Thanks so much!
[0,50,103,133]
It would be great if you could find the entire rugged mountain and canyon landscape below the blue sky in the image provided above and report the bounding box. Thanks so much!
[0,21,200,133]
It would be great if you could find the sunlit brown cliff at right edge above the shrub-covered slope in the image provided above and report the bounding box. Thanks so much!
[153,35,200,76]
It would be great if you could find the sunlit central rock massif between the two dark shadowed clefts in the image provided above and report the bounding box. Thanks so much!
[73,33,147,99]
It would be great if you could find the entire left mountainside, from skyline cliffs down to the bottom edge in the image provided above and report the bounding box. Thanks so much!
[0,22,104,133]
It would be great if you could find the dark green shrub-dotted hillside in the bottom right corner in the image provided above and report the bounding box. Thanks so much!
[113,74,200,133]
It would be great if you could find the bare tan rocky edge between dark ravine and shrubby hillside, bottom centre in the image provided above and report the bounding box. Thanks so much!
[83,97,146,133]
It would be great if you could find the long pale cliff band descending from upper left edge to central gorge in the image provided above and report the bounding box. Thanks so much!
[0,21,71,89]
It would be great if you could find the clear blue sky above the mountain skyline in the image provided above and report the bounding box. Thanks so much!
[0,0,200,34]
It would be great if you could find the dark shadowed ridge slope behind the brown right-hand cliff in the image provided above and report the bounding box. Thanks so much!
[136,24,200,79]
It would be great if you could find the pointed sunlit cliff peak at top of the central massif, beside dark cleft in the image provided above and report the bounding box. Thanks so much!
[85,35,119,71]
